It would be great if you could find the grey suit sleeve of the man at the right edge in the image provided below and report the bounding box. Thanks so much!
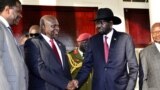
[139,51,148,90]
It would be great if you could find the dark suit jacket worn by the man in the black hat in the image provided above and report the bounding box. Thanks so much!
[76,30,138,90]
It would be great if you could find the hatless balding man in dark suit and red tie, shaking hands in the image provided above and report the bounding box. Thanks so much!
[25,15,71,90]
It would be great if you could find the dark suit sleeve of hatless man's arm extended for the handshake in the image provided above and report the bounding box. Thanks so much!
[25,41,69,90]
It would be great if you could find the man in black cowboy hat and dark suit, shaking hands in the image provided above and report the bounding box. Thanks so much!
[73,8,138,90]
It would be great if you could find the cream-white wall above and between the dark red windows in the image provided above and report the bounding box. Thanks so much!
[20,0,149,32]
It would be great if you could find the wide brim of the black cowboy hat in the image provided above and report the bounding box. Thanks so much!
[93,16,122,25]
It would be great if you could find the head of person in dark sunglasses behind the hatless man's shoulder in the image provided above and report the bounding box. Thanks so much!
[29,25,40,38]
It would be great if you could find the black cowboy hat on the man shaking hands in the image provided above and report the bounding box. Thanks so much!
[94,8,121,25]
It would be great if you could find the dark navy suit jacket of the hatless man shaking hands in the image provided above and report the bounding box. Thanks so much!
[25,35,71,90]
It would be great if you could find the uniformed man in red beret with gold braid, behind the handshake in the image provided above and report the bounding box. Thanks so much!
[68,33,92,90]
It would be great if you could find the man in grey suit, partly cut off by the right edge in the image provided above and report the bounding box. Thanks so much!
[139,22,160,90]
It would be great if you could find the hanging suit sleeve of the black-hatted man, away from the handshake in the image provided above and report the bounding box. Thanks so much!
[126,37,138,90]
